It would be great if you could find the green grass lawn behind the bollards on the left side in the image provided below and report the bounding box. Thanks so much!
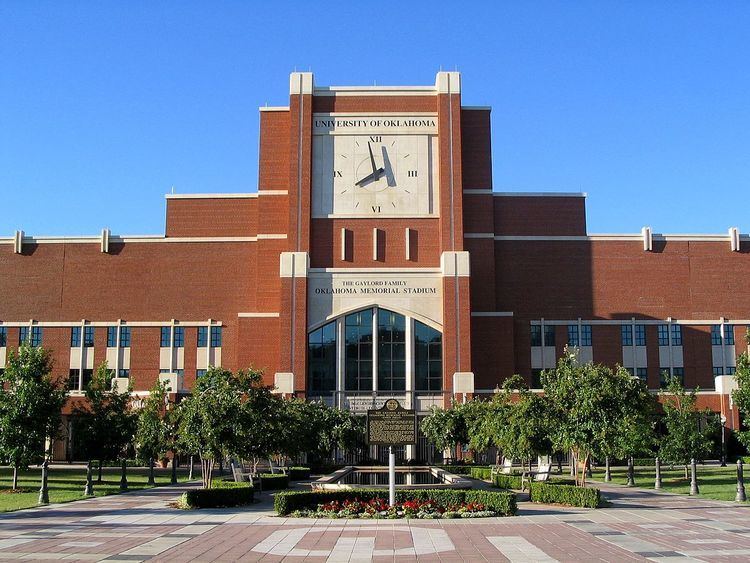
[0,465,200,512]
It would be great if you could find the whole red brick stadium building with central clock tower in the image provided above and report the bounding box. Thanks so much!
[0,72,750,457]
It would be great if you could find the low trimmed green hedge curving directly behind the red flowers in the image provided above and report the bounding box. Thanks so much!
[273,489,518,516]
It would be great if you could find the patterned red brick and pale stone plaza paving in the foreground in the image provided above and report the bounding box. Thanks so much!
[0,484,750,562]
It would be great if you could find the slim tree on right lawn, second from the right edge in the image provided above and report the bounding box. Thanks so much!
[659,377,720,478]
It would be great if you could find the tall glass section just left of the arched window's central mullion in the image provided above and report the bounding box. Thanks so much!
[344,309,372,391]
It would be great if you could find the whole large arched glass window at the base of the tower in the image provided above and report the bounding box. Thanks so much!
[308,307,443,411]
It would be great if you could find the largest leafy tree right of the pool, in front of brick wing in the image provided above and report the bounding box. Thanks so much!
[542,350,648,486]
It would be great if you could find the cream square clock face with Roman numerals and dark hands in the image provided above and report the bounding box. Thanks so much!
[312,114,437,217]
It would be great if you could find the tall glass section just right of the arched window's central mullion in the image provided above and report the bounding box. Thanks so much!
[378,309,406,391]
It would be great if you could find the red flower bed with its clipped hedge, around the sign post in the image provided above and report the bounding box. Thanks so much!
[274,489,517,518]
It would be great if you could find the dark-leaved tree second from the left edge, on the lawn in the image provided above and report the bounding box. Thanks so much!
[74,362,137,483]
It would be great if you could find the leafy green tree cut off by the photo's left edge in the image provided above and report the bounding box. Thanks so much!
[0,343,66,489]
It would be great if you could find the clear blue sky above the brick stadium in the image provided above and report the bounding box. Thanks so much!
[0,0,750,236]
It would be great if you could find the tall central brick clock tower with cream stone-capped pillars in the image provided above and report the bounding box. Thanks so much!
[276,72,474,418]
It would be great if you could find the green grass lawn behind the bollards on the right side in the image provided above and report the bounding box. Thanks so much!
[594,464,750,500]
